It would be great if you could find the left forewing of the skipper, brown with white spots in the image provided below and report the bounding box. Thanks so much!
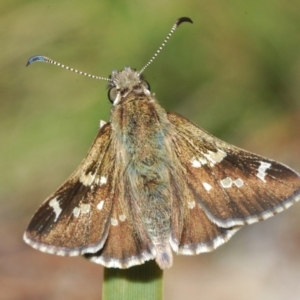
[24,124,115,256]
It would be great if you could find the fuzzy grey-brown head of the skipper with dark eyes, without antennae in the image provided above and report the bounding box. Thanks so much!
[108,67,151,105]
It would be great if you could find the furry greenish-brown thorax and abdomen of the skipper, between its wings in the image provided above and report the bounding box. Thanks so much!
[111,71,173,264]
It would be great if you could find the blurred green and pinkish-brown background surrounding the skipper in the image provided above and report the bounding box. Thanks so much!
[0,0,300,300]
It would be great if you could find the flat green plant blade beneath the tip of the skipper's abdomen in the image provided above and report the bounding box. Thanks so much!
[102,260,163,300]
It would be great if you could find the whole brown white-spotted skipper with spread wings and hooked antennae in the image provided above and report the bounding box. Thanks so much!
[24,17,300,269]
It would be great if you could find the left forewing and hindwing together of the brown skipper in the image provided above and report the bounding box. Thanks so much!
[24,124,154,268]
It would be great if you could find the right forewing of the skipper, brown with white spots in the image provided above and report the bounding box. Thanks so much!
[168,114,300,228]
